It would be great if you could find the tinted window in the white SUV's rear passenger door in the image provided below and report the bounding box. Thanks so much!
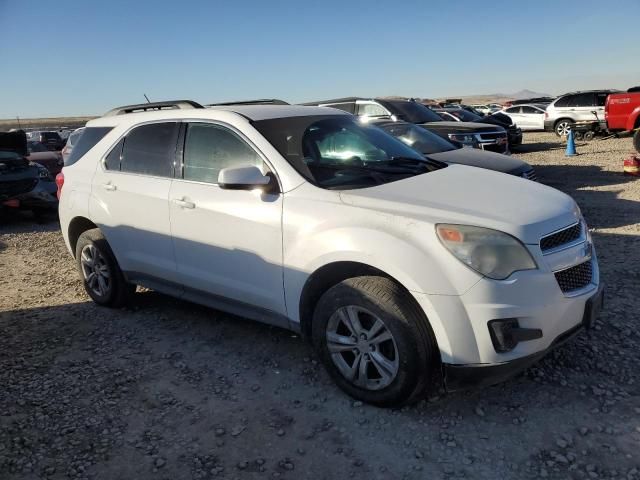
[119,122,178,177]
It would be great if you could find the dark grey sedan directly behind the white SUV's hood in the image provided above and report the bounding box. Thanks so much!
[371,119,538,181]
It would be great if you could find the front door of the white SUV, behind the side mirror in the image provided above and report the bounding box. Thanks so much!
[169,122,286,315]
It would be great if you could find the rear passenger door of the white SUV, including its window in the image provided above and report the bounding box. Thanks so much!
[90,122,179,281]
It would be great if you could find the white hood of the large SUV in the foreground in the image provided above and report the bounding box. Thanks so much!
[340,165,580,244]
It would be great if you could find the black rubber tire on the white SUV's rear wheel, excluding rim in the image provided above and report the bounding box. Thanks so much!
[76,228,136,308]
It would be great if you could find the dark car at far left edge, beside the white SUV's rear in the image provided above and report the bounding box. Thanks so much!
[0,131,58,215]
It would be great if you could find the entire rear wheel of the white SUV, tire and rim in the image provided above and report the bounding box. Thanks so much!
[76,228,135,307]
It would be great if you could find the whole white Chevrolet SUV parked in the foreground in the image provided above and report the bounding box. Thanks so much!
[58,102,602,406]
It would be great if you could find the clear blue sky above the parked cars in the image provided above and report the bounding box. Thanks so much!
[0,0,640,118]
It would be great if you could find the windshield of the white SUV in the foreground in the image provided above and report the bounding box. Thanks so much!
[253,115,442,189]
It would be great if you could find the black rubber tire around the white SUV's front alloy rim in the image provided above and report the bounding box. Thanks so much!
[312,276,440,407]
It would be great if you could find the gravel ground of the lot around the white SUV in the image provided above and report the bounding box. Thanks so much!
[0,133,640,480]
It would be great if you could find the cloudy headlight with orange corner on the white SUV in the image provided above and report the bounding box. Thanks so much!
[436,224,538,280]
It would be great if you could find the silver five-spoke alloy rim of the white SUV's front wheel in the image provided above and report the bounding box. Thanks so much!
[326,305,400,390]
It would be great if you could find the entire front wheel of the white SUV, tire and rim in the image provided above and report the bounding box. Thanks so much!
[313,276,438,407]
